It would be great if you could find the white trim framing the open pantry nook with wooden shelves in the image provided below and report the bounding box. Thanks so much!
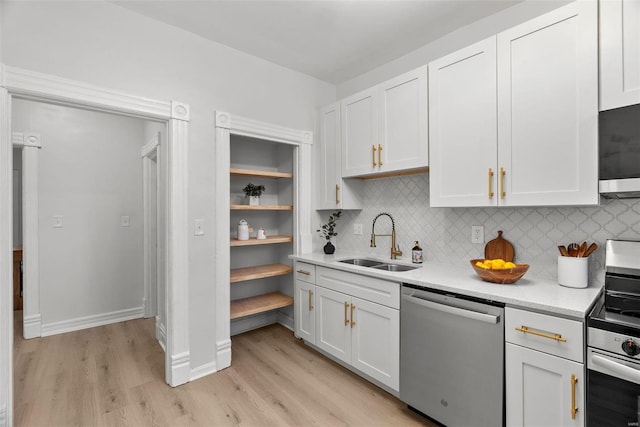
[214,111,313,370]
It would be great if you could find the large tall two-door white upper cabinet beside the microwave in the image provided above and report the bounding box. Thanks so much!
[429,1,598,206]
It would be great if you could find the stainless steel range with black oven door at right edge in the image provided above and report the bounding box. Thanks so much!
[587,240,640,427]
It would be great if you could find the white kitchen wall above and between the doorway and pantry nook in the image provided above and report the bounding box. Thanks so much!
[0,1,335,369]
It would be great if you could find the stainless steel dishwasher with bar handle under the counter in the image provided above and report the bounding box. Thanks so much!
[400,284,504,427]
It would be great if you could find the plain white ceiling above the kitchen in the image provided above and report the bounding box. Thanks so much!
[111,0,522,84]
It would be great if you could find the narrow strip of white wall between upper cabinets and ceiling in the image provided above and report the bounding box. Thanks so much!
[338,0,572,99]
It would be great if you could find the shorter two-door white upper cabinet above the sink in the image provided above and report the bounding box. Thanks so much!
[341,66,428,177]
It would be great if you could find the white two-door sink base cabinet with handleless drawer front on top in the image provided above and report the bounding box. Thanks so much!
[315,267,400,391]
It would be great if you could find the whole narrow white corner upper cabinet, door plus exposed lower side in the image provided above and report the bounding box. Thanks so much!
[317,102,361,209]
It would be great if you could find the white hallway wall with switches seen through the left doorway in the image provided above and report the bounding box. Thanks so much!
[12,99,145,328]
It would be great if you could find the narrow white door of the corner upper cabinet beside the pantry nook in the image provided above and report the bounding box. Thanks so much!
[318,102,342,209]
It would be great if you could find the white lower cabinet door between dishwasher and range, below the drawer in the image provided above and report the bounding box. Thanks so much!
[505,343,585,427]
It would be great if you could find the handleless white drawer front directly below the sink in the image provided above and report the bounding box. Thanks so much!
[316,267,400,309]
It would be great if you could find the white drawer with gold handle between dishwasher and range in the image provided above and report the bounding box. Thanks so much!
[504,307,584,363]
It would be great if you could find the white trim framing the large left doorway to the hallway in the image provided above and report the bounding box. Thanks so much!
[0,65,190,425]
